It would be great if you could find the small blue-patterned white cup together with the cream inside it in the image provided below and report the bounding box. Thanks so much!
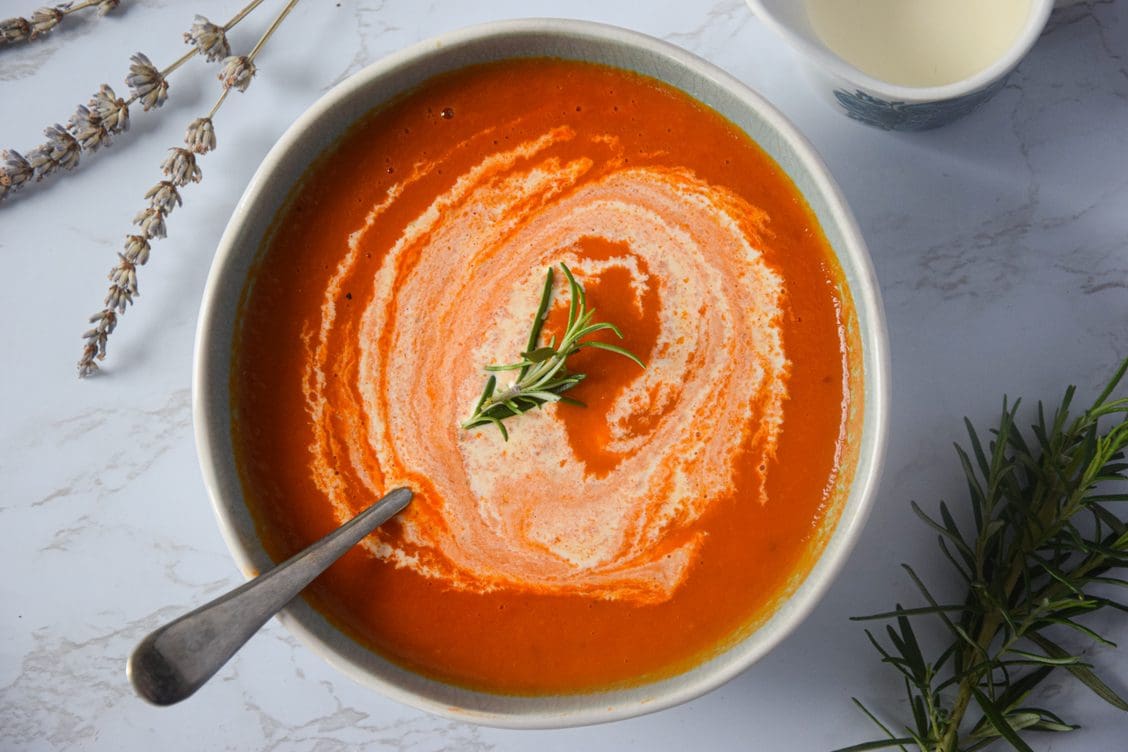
[747,0,1076,131]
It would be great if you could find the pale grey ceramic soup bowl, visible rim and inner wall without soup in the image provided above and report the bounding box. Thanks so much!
[193,20,889,727]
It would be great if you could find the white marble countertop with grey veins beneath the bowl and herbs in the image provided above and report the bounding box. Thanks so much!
[0,0,1128,752]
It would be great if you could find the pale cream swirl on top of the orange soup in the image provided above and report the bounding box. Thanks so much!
[305,126,787,602]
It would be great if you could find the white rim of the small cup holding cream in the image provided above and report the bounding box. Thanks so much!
[744,0,1054,103]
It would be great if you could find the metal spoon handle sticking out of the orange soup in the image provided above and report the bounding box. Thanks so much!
[126,488,412,705]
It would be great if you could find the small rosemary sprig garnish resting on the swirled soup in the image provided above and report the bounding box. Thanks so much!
[461,264,646,441]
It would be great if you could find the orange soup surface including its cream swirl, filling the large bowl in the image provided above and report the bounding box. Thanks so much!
[232,60,861,695]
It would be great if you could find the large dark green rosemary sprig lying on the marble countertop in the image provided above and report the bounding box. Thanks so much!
[838,361,1128,752]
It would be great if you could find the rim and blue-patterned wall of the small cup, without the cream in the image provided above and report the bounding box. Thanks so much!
[747,0,1078,131]
